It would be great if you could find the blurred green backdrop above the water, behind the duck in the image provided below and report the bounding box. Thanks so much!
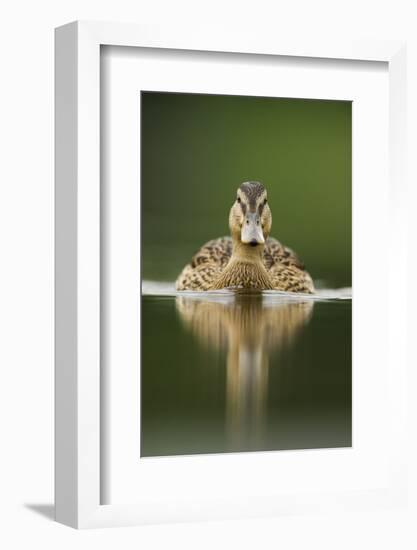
[141,92,352,287]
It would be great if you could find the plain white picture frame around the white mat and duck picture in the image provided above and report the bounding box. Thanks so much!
[55,22,406,528]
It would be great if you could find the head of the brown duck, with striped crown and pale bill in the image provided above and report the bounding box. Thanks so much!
[229,181,272,249]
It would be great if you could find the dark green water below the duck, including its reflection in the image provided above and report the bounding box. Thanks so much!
[141,293,352,456]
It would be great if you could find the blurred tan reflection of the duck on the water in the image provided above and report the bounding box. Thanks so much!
[176,292,314,450]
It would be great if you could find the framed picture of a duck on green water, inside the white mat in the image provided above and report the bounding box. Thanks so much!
[138,90,352,457]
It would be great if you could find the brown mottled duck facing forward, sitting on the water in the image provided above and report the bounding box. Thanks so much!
[176,181,314,294]
